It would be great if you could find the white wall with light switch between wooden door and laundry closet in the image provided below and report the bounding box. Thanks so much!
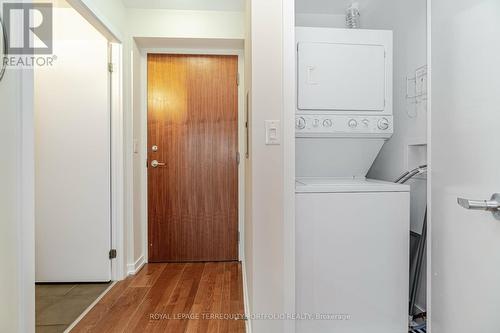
[245,0,285,333]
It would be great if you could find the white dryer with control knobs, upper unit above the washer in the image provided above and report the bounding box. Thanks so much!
[296,27,394,177]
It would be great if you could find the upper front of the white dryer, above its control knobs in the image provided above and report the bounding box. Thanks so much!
[296,27,393,115]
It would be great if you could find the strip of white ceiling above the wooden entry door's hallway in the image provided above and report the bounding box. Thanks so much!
[122,0,245,11]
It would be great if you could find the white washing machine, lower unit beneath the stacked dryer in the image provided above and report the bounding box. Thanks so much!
[295,178,410,333]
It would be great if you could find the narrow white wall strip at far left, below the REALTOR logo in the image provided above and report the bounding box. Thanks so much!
[0,59,26,332]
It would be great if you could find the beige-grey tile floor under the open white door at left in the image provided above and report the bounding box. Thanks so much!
[35,283,111,333]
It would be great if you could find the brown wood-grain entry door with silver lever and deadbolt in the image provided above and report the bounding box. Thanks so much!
[148,54,238,262]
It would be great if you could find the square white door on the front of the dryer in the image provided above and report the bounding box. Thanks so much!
[298,42,386,111]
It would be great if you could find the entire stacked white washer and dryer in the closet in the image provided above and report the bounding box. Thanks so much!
[296,27,410,333]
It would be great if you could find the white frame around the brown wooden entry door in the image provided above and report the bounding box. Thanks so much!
[139,47,246,263]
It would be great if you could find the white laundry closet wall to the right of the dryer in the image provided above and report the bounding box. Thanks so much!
[361,0,427,309]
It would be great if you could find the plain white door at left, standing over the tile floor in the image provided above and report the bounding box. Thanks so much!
[35,8,111,282]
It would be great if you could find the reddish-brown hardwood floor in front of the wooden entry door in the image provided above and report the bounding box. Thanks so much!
[71,262,245,333]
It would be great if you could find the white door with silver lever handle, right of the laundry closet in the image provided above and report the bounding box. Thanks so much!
[431,0,500,333]
